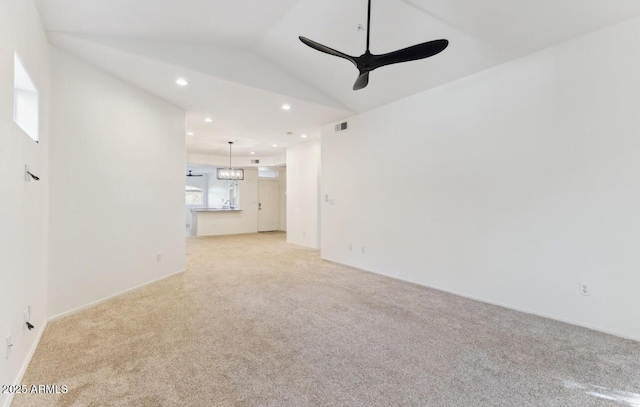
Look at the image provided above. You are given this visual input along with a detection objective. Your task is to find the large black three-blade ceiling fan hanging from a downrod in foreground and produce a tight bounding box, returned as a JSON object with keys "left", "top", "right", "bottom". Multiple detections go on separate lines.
{"left": 298, "top": 0, "right": 449, "bottom": 90}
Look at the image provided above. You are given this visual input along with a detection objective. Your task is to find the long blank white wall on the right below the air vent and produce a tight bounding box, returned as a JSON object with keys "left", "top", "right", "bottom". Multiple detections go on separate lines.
{"left": 320, "top": 20, "right": 640, "bottom": 339}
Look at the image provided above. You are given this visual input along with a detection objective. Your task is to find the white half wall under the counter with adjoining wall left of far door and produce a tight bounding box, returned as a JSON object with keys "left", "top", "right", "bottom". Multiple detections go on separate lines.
{"left": 192, "top": 168, "right": 258, "bottom": 236}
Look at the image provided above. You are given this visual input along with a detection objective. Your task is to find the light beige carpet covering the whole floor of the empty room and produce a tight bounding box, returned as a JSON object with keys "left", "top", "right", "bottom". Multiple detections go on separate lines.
{"left": 13, "top": 234, "right": 640, "bottom": 407}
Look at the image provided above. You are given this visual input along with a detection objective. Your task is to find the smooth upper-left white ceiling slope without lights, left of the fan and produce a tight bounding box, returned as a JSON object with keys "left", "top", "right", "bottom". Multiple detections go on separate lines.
{"left": 38, "top": 0, "right": 298, "bottom": 46}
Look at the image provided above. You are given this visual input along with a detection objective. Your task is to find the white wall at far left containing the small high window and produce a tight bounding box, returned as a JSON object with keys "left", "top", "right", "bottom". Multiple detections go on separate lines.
{"left": 0, "top": 0, "right": 50, "bottom": 405}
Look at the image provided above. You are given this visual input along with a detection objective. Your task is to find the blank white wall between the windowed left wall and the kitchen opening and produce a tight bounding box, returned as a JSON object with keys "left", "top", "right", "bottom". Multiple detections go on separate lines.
{"left": 49, "top": 49, "right": 185, "bottom": 316}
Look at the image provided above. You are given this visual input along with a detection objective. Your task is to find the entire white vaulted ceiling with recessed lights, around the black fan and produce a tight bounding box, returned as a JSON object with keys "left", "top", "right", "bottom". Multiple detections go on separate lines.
{"left": 38, "top": 0, "right": 640, "bottom": 156}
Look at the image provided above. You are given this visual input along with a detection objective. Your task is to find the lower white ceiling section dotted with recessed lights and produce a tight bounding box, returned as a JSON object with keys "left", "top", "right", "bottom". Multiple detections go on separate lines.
{"left": 49, "top": 33, "right": 350, "bottom": 158}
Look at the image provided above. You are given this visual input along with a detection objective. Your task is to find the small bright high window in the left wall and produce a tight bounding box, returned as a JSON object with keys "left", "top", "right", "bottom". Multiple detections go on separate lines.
{"left": 13, "top": 53, "right": 40, "bottom": 142}
